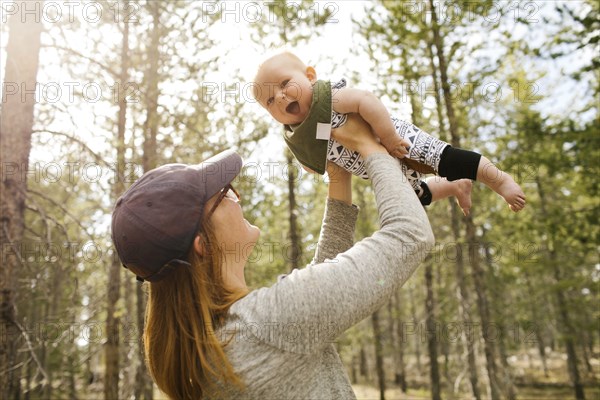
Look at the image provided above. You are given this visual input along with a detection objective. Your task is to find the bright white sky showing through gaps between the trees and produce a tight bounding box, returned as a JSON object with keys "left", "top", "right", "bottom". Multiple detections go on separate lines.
{"left": 0, "top": 0, "right": 597, "bottom": 268}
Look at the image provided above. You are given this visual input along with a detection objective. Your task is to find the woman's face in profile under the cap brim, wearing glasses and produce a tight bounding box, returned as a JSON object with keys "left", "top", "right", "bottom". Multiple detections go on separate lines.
{"left": 204, "top": 189, "right": 260, "bottom": 261}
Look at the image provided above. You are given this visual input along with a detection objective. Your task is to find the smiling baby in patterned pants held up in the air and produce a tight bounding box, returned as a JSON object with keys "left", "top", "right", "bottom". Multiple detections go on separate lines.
{"left": 253, "top": 52, "right": 526, "bottom": 215}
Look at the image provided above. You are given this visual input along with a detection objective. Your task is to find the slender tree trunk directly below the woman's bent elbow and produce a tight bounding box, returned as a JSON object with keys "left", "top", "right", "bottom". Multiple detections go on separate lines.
{"left": 425, "top": 259, "right": 442, "bottom": 400}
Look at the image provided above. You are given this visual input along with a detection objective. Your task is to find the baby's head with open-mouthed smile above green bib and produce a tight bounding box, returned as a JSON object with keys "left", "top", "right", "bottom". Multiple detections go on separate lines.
{"left": 253, "top": 52, "right": 317, "bottom": 125}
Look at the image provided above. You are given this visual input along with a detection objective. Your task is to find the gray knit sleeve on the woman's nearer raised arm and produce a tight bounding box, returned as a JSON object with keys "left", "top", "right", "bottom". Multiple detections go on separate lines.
{"left": 234, "top": 153, "right": 434, "bottom": 354}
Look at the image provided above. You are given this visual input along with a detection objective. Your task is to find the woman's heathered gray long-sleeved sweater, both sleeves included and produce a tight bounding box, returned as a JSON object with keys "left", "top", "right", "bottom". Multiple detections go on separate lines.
{"left": 209, "top": 154, "right": 434, "bottom": 400}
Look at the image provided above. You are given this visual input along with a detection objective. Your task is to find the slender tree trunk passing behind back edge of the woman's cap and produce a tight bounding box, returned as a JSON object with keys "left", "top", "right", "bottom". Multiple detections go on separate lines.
{"left": 104, "top": 7, "right": 129, "bottom": 399}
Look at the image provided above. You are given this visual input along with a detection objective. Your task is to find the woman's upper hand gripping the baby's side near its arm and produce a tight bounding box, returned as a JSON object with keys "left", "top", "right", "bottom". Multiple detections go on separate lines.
{"left": 331, "top": 114, "right": 388, "bottom": 158}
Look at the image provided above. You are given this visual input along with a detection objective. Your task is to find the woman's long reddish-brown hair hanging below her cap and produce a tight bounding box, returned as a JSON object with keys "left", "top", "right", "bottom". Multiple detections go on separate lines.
{"left": 144, "top": 221, "right": 247, "bottom": 399}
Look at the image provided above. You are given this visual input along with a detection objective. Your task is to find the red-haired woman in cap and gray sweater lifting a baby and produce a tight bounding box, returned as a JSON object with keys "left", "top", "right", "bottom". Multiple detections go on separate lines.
{"left": 112, "top": 116, "right": 433, "bottom": 399}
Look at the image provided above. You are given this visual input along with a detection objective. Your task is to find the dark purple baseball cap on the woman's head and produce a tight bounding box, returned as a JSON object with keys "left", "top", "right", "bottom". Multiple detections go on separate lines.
{"left": 112, "top": 150, "right": 242, "bottom": 282}
